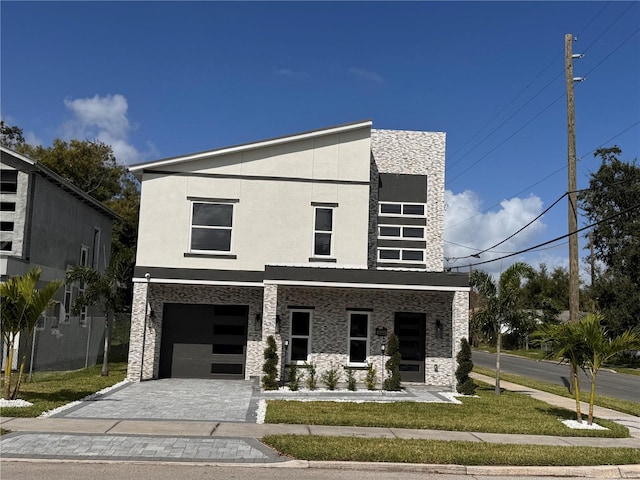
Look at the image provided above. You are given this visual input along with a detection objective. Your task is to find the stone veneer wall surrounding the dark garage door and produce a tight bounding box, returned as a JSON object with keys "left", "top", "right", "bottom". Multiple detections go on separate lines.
{"left": 127, "top": 282, "right": 264, "bottom": 381}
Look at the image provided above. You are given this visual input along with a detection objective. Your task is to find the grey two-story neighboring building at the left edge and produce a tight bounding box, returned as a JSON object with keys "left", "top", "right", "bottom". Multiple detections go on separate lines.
{"left": 0, "top": 147, "right": 117, "bottom": 371}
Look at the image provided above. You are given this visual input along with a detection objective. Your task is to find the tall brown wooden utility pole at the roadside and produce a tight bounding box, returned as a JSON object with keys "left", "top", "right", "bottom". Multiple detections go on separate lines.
{"left": 564, "top": 33, "right": 584, "bottom": 322}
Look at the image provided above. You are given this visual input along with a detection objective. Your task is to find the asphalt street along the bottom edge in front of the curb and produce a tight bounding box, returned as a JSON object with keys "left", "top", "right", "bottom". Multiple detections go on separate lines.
{"left": 0, "top": 461, "right": 624, "bottom": 480}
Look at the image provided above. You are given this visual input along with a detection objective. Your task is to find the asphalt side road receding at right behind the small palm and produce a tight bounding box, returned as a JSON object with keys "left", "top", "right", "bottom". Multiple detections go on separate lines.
{"left": 472, "top": 351, "right": 640, "bottom": 402}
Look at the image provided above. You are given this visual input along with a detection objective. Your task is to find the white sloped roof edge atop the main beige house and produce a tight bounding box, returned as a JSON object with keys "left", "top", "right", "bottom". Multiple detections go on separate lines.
{"left": 129, "top": 120, "right": 373, "bottom": 178}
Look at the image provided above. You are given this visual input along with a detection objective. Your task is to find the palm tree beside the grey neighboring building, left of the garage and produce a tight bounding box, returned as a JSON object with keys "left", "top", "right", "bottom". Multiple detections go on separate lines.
{"left": 65, "top": 250, "right": 133, "bottom": 377}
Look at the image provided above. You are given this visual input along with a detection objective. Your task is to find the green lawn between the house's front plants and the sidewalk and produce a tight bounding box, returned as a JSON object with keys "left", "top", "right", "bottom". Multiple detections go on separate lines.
{"left": 265, "top": 384, "right": 629, "bottom": 437}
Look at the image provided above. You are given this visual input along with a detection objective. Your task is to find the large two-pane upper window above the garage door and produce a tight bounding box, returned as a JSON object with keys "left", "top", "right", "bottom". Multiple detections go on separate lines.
{"left": 191, "top": 202, "right": 233, "bottom": 252}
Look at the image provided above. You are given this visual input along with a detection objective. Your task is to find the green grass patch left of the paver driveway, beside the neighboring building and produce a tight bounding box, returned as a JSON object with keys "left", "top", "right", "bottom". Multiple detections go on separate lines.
{"left": 0, "top": 362, "right": 127, "bottom": 417}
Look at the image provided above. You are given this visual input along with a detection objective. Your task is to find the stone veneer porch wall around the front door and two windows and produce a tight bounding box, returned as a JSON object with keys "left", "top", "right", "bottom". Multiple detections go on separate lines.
{"left": 276, "top": 286, "right": 466, "bottom": 388}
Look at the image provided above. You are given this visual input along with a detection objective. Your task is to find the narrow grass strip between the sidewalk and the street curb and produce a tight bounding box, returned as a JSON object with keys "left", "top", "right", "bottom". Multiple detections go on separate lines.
{"left": 262, "top": 435, "right": 640, "bottom": 466}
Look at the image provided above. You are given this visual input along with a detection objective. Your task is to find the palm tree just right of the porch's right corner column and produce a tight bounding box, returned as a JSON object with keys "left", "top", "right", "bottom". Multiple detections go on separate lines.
{"left": 471, "top": 262, "right": 535, "bottom": 395}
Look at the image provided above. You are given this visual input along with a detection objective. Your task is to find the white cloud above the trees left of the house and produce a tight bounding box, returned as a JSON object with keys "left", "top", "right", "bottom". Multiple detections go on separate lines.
{"left": 63, "top": 94, "right": 141, "bottom": 165}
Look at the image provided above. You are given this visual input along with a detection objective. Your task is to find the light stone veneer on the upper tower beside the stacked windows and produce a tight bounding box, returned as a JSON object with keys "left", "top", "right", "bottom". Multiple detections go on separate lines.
{"left": 371, "top": 129, "right": 446, "bottom": 272}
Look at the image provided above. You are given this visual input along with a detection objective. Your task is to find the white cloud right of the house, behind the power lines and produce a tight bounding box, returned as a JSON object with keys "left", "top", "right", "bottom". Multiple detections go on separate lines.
{"left": 444, "top": 190, "right": 546, "bottom": 273}
